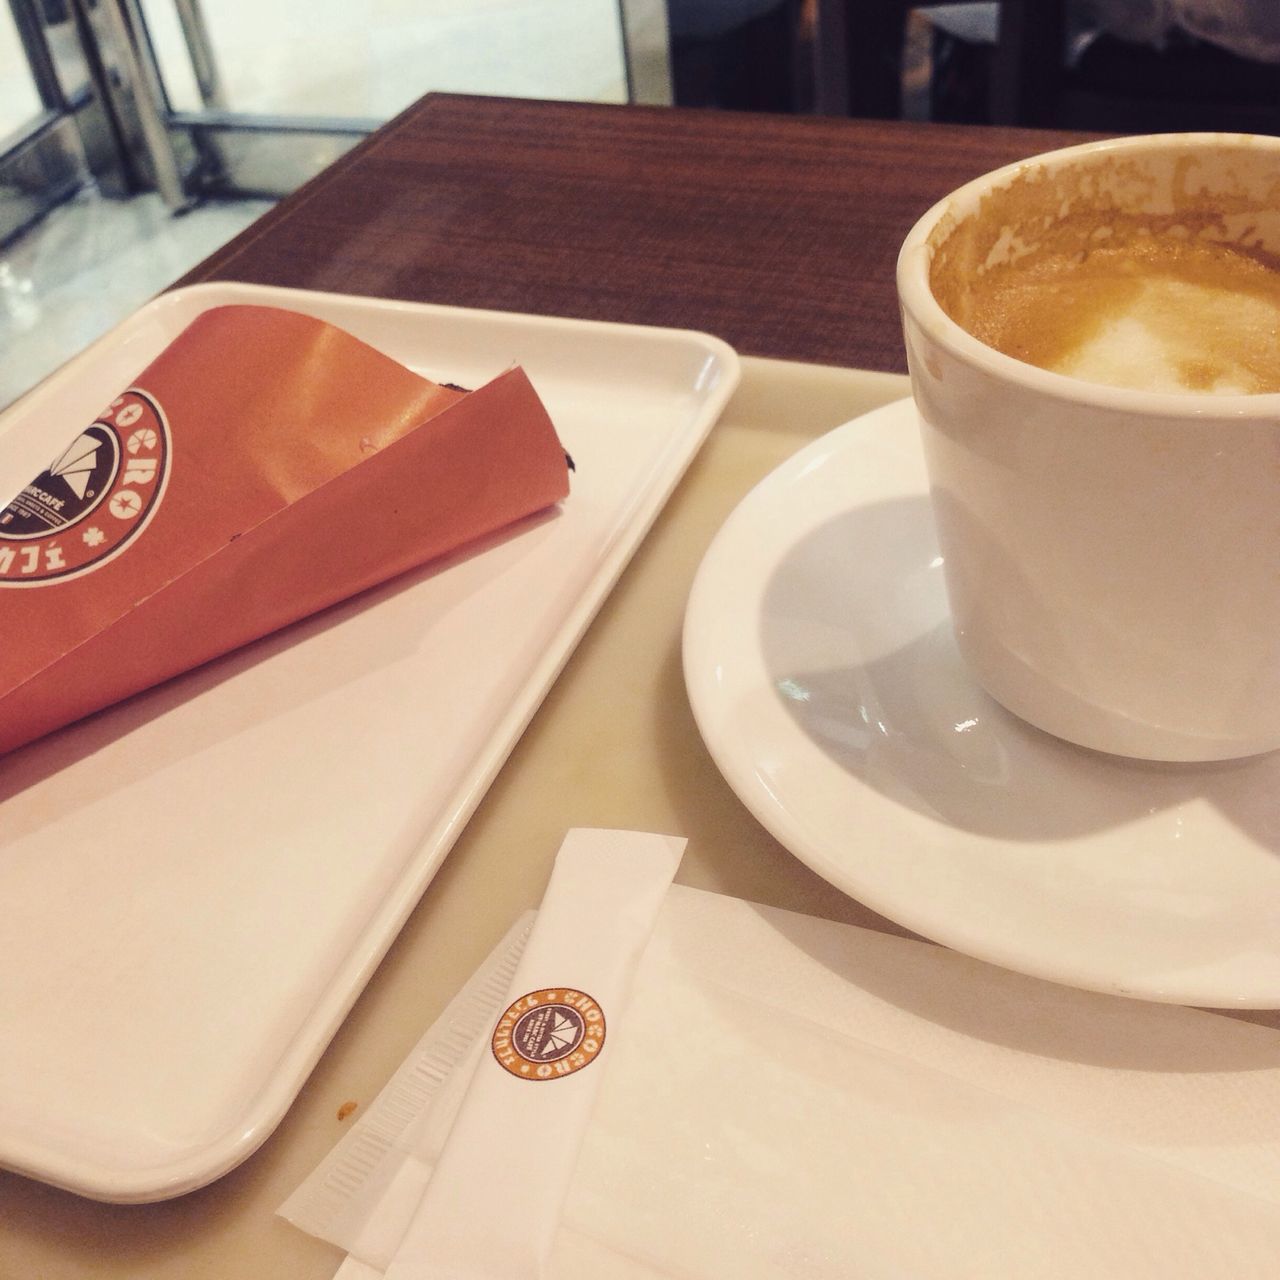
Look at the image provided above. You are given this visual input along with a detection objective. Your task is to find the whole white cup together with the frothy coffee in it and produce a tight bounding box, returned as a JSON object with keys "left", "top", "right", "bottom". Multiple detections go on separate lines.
{"left": 899, "top": 134, "right": 1280, "bottom": 760}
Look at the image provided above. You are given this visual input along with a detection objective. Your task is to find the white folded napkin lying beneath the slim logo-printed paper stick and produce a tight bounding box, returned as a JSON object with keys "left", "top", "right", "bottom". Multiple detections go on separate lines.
{"left": 282, "top": 839, "right": 1280, "bottom": 1280}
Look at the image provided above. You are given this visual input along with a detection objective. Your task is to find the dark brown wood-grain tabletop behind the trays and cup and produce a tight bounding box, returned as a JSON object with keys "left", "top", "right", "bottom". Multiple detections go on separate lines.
{"left": 186, "top": 93, "right": 1084, "bottom": 371}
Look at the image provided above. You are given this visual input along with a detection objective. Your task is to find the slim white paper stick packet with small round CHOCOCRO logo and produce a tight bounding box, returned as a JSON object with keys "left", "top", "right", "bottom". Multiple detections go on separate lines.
{"left": 385, "top": 829, "right": 685, "bottom": 1280}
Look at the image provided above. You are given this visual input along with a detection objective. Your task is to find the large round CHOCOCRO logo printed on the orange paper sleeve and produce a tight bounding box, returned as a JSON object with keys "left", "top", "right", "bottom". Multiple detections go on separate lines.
{"left": 0, "top": 390, "right": 170, "bottom": 586}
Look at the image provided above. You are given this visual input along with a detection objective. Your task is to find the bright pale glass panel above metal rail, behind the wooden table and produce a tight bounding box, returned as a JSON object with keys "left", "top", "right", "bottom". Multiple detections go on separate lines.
{"left": 143, "top": 0, "right": 627, "bottom": 120}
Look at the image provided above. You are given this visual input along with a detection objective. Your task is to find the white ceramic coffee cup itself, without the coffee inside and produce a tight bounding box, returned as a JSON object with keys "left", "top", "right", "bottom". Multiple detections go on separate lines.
{"left": 897, "top": 134, "right": 1280, "bottom": 760}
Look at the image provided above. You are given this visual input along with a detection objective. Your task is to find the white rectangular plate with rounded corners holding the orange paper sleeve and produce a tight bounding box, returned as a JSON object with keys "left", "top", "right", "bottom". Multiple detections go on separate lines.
{"left": 0, "top": 284, "right": 739, "bottom": 1202}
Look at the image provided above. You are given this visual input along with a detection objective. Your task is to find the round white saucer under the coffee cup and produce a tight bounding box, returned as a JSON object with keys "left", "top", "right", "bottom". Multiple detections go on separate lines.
{"left": 685, "top": 401, "right": 1280, "bottom": 1009}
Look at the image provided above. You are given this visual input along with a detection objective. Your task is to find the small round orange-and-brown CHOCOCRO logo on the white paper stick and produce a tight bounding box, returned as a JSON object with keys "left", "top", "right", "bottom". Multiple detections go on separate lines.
{"left": 493, "top": 987, "right": 604, "bottom": 1080}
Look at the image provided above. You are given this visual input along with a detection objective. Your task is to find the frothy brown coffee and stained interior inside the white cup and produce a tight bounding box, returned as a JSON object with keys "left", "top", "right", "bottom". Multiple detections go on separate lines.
{"left": 931, "top": 149, "right": 1280, "bottom": 393}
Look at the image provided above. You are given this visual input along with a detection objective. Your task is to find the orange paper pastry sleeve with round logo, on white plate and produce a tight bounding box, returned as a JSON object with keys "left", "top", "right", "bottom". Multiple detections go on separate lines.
{"left": 0, "top": 306, "right": 568, "bottom": 751}
